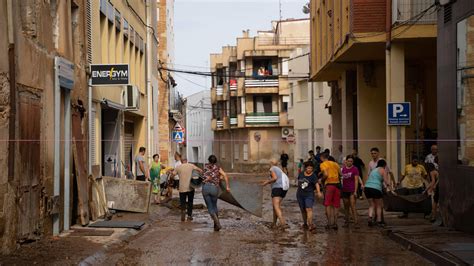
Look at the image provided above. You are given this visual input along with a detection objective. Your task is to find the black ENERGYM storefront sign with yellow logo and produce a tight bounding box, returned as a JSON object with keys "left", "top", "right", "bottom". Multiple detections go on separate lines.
{"left": 91, "top": 64, "right": 130, "bottom": 86}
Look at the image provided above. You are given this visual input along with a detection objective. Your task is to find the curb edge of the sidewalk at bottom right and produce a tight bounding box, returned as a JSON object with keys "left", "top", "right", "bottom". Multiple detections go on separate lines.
{"left": 385, "top": 229, "right": 465, "bottom": 265}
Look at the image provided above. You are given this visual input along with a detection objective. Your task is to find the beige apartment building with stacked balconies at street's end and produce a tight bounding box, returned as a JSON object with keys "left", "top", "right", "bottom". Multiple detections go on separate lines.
{"left": 211, "top": 19, "right": 309, "bottom": 172}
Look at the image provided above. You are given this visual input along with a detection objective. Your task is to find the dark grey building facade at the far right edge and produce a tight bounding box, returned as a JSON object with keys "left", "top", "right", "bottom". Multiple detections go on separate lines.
{"left": 438, "top": 0, "right": 474, "bottom": 233}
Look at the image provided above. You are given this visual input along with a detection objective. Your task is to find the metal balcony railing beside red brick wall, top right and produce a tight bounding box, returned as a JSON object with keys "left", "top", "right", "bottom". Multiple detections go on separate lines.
{"left": 392, "top": 0, "right": 437, "bottom": 24}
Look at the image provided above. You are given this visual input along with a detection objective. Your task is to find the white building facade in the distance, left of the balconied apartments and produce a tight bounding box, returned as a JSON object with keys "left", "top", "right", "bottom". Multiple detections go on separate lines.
{"left": 186, "top": 90, "right": 214, "bottom": 165}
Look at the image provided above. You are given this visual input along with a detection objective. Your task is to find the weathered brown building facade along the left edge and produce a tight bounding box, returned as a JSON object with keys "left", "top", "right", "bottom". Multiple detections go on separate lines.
{"left": 0, "top": 0, "right": 88, "bottom": 254}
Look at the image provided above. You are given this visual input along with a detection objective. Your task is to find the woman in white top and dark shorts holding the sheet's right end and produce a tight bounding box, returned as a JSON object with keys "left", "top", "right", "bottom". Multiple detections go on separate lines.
{"left": 262, "top": 159, "right": 288, "bottom": 229}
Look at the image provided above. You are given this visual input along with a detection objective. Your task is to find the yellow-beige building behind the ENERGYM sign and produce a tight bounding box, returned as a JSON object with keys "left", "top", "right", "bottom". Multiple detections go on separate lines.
{"left": 90, "top": 0, "right": 158, "bottom": 177}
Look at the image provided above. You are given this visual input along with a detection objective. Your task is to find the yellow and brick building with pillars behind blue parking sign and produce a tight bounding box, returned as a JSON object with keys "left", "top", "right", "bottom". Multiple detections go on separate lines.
{"left": 311, "top": 0, "right": 438, "bottom": 178}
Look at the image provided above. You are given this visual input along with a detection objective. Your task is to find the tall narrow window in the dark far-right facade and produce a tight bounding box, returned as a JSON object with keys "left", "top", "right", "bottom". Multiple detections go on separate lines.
{"left": 456, "top": 15, "right": 474, "bottom": 166}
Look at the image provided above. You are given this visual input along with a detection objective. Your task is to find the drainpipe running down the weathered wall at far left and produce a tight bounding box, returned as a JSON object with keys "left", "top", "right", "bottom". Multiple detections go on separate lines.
{"left": 7, "top": 0, "right": 16, "bottom": 182}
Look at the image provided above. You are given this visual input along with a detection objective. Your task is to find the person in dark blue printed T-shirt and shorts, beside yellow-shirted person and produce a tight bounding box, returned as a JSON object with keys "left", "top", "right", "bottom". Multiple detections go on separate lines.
{"left": 296, "top": 162, "right": 323, "bottom": 232}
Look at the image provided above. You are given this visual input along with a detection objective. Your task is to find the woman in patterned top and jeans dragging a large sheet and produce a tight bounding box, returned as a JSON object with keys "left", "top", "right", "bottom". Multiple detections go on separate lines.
{"left": 202, "top": 155, "right": 230, "bottom": 231}
